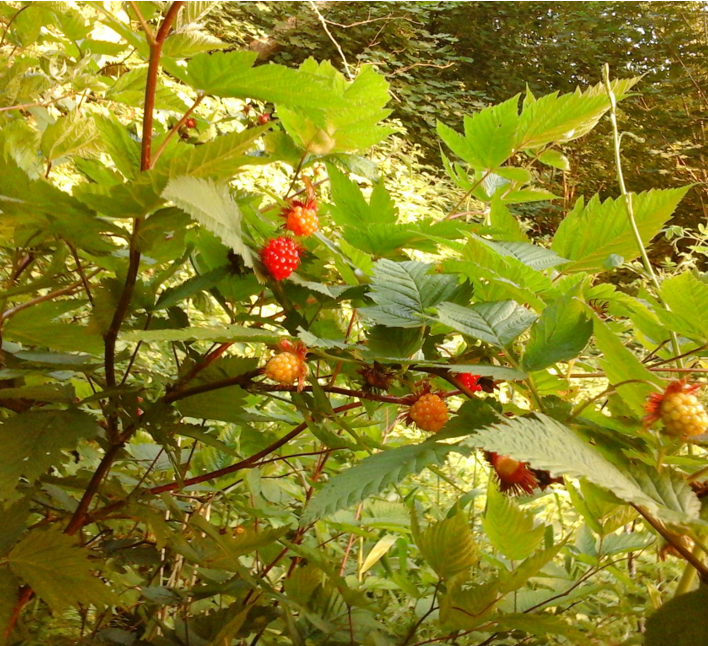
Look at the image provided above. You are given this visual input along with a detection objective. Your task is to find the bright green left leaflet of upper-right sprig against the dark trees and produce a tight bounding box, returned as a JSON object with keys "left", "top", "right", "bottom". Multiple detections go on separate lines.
{"left": 438, "top": 94, "right": 519, "bottom": 170}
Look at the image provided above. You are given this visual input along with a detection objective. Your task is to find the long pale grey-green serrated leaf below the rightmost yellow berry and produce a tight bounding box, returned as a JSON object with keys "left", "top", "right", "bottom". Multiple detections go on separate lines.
{"left": 472, "top": 414, "right": 699, "bottom": 522}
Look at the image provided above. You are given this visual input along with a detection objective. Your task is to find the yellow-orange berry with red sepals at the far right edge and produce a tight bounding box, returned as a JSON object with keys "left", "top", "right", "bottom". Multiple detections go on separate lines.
{"left": 644, "top": 381, "right": 708, "bottom": 439}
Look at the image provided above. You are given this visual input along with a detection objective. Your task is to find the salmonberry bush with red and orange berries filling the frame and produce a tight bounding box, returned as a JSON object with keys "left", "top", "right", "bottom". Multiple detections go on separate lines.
{"left": 0, "top": 2, "right": 708, "bottom": 646}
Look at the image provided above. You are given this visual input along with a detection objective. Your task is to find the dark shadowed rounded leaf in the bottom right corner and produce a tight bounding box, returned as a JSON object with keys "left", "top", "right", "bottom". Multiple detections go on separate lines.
{"left": 645, "top": 584, "right": 708, "bottom": 646}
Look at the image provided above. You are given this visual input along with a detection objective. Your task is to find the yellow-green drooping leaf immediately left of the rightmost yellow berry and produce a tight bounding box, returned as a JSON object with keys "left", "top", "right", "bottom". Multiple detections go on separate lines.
{"left": 593, "top": 317, "right": 665, "bottom": 418}
